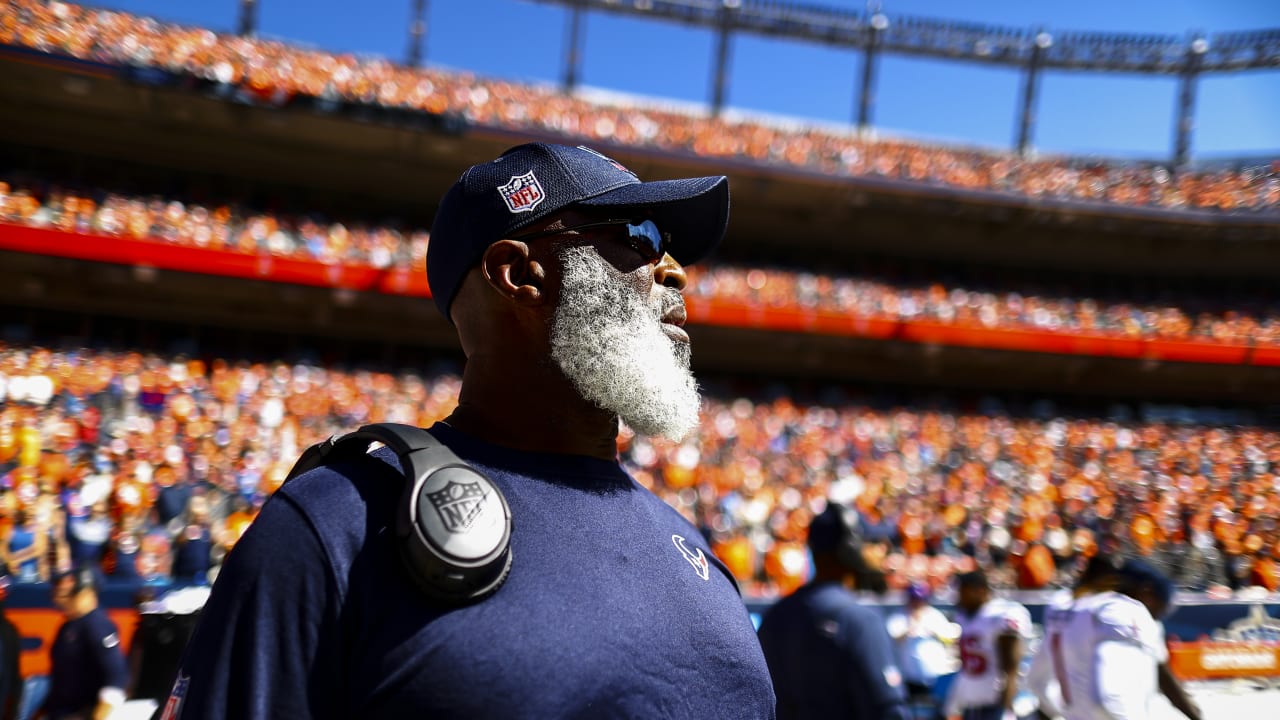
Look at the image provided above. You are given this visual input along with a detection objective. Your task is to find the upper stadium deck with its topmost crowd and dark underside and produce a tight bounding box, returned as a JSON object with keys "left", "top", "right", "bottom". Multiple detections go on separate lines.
{"left": 0, "top": 0, "right": 1280, "bottom": 288}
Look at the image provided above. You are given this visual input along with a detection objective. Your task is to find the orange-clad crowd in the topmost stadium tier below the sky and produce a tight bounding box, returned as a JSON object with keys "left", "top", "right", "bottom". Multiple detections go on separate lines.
{"left": 0, "top": 0, "right": 1280, "bottom": 211}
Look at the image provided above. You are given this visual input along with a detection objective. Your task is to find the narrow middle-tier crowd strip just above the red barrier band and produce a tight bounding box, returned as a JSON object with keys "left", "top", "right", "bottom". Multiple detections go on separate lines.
{"left": 0, "top": 178, "right": 1280, "bottom": 346}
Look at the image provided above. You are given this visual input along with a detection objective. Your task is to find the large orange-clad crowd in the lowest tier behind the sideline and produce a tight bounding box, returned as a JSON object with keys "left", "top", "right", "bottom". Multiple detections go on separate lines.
{"left": 0, "top": 345, "right": 1280, "bottom": 596}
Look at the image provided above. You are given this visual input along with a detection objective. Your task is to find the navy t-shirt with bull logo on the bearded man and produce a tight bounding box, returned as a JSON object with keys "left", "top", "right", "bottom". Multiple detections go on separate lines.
{"left": 168, "top": 424, "right": 773, "bottom": 720}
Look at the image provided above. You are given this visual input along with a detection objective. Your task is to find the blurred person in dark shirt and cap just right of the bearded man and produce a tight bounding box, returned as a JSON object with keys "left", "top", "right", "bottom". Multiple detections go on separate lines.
{"left": 759, "top": 503, "right": 911, "bottom": 720}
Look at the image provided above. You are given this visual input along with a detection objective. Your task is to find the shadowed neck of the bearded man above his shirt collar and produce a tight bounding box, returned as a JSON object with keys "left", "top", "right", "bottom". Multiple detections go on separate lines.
{"left": 445, "top": 356, "right": 618, "bottom": 460}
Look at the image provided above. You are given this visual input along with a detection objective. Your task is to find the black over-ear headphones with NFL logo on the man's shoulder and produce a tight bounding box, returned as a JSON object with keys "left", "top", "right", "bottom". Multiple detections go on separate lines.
{"left": 285, "top": 423, "right": 511, "bottom": 605}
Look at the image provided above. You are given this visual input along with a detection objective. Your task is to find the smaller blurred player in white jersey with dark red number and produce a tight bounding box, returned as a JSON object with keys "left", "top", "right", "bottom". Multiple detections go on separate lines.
{"left": 943, "top": 570, "right": 1032, "bottom": 720}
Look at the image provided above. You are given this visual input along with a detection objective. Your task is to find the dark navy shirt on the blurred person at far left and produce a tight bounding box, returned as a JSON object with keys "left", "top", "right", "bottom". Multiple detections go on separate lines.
{"left": 45, "top": 609, "right": 129, "bottom": 717}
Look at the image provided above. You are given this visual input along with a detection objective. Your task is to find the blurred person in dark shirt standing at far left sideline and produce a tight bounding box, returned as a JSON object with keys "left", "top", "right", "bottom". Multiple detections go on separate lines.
{"left": 42, "top": 568, "right": 129, "bottom": 720}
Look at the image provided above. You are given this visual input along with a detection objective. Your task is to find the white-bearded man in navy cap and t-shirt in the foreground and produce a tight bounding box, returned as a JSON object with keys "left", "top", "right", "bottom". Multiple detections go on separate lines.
{"left": 164, "top": 143, "right": 774, "bottom": 720}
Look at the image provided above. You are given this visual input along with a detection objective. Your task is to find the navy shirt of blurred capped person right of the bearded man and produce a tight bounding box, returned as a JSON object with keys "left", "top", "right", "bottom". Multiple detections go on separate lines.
{"left": 760, "top": 582, "right": 911, "bottom": 720}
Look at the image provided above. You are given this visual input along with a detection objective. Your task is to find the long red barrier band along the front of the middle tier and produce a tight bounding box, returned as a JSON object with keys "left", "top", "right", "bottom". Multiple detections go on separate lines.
{"left": 0, "top": 223, "right": 1280, "bottom": 366}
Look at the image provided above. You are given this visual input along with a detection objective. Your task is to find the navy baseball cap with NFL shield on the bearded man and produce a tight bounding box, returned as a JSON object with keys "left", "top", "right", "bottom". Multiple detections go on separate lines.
{"left": 426, "top": 142, "right": 728, "bottom": 322}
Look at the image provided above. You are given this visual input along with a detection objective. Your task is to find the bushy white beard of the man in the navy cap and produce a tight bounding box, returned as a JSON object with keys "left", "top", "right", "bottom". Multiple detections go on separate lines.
{"left": 550, "top": 247, "right": 701, "bottom": 441}
